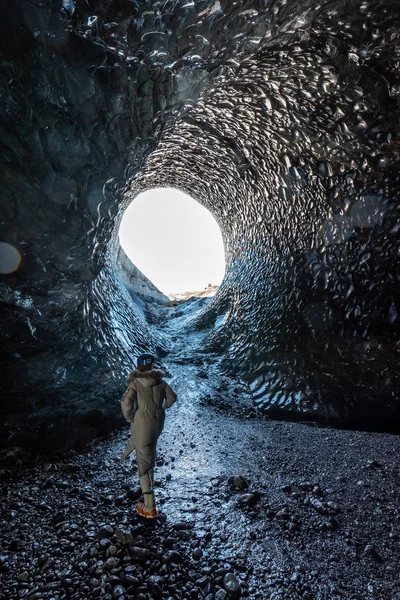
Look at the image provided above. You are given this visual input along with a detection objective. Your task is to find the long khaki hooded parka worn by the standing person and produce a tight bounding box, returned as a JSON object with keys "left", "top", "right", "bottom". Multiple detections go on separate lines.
{"left": 121, "top": 369, "right": 176, "bottom": 477}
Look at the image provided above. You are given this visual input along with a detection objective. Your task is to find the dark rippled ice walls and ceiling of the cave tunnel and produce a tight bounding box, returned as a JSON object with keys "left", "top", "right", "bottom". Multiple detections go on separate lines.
{"left": 0, "top": 0, "right": 400, "bottom": 447}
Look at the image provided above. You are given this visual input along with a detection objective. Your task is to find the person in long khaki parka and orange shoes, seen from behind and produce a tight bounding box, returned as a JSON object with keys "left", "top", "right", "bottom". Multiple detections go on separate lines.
{"left": 121, "top": 354, "right": 176, "bottom": 519}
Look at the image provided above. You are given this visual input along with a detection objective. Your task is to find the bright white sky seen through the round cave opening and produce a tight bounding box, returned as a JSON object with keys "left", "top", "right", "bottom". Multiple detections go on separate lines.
{"left": 119, "top": 188, "right": 225, "bottom": 294}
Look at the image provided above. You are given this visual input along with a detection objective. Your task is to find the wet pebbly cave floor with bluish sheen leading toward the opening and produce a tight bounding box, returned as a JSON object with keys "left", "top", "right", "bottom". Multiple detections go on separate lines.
{"left": 0, "top": 300, "right": 400, "bottom": 600}
